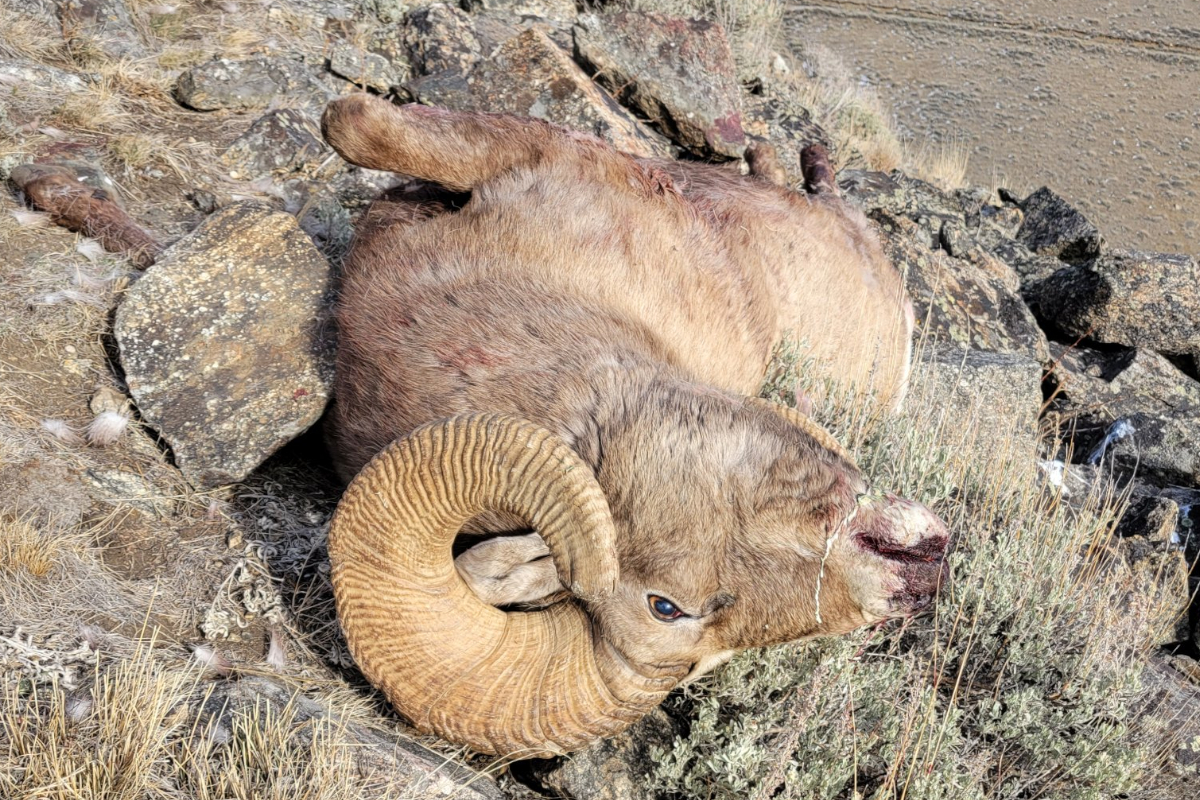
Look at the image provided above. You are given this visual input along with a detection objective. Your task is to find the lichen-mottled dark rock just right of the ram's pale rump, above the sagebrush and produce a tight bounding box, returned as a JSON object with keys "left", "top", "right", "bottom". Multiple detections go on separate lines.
{"left": 872, "top": 211, "right": 1049, "bottom": 362}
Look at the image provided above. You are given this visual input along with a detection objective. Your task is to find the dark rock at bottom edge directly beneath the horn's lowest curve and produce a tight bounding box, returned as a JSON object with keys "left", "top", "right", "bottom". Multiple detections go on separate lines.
{"left": 535, "top": 709, "right": 676, "bottom": 800}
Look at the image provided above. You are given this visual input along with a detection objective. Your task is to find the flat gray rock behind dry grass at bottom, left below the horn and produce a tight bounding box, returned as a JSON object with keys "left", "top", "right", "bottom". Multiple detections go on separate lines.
{"left": 200, "top": 675, "right": 504, "bottom": 800}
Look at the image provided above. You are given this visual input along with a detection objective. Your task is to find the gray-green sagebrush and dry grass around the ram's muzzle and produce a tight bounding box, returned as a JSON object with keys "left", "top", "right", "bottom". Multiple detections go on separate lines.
{"left": 656, "top": 340, "right": 1178, "bottom": 800}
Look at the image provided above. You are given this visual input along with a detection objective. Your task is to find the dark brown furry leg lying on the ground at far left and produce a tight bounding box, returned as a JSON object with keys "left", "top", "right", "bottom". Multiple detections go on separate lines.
{"left": 10, "top": 164, "right": 162, "bottom": 267}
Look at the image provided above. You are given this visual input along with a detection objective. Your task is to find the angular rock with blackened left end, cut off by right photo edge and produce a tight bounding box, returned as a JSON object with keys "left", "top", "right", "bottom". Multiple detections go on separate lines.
{"left": 1026, "top": 251, "right": 1200, "bottom": 369}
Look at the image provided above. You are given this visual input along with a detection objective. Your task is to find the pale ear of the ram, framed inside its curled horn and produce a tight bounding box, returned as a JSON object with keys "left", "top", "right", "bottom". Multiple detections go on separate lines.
{"left": 454, "top": 534, "right": 565, "bottom": 606}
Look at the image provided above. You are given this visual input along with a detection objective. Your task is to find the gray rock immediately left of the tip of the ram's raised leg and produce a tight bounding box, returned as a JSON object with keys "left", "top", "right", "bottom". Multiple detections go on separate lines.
{"left": 221, "top": 108, "right": 332, "bottom": 179}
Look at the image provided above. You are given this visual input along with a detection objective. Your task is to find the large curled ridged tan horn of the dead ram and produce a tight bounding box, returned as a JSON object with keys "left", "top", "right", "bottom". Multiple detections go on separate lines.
{"left": 329, "top": 414, "right": 677, "bottom": 757}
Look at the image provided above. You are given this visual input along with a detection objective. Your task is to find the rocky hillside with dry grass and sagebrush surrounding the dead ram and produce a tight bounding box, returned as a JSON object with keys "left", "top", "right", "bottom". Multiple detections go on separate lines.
{"left": 0, "top": 0, "right": 1200, "bottom": 800}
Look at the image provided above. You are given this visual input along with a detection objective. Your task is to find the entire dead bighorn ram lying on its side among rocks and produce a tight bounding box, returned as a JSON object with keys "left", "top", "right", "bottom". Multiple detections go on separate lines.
{"left": 323, "top": 95, "right": 947, "bottom": 756}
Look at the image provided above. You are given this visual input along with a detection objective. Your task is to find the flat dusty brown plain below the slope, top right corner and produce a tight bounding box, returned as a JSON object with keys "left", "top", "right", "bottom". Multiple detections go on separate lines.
{"left": 787, "top": 0, "right": 1200, "bottom": 253}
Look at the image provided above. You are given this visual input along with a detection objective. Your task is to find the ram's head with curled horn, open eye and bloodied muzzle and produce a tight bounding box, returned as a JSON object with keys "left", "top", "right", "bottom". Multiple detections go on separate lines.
{"left": 330, "top": 392, "right": 948, "bottom": 757}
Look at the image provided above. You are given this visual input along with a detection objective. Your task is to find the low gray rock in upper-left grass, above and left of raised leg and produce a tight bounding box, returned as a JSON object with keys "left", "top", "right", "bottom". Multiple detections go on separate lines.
{"left": 175, "top": 58, "right": 334, "bottom": 112}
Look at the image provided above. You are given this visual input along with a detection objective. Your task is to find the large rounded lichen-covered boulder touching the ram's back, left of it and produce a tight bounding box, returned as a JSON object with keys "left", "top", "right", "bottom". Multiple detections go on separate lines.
{"left": 115, "top": 204, "right": 332, "bottom": 488}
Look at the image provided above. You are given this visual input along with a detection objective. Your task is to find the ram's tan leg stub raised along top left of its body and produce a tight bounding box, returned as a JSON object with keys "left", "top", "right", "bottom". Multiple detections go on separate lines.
{"left": 320, "top": 95, "right": 557, "bottom": 192}
